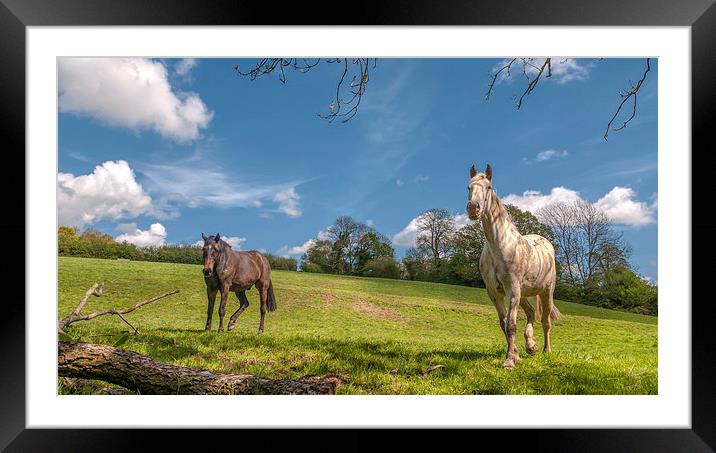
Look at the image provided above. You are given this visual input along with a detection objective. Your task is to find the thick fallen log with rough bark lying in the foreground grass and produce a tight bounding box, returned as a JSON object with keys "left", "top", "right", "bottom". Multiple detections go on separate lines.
{"left": 57, "top": 341, "right": 341, "bottom": 395}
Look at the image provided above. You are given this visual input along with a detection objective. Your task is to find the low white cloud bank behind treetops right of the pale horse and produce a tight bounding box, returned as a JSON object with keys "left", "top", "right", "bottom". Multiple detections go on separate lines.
{"left": 502, "top": 186, "right": 657, "bottom": 228}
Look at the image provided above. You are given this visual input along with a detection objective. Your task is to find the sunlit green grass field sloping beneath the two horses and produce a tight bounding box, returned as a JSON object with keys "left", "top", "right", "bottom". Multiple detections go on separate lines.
{"left": 58, "top": 257, "right": 658, "bottom": 394}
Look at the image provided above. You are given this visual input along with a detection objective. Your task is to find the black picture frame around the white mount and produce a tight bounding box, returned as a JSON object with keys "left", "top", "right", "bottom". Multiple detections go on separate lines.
{"left": 0, "top": 0, "right": 716, "bottom": 452}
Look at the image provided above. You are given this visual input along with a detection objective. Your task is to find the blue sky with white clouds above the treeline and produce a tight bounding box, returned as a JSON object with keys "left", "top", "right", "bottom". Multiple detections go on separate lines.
{"left": 58, "top": 59, "right": 658, "bottom": 280}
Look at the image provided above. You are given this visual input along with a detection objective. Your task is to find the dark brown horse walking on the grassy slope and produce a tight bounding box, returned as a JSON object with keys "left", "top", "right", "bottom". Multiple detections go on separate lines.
{"left": 201, "top": 233, "right": 276, "bottom": 333}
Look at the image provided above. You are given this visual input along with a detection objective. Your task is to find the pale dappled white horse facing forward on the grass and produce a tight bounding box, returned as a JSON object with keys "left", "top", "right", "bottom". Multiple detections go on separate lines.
{"left": 467, "top": 164, "right": 561, "bottom": 369}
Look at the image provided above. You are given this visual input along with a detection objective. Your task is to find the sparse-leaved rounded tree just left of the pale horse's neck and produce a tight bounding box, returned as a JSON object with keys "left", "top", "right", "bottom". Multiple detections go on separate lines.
{"left": 415, "top": 209, "right": 455, "bottom": 267}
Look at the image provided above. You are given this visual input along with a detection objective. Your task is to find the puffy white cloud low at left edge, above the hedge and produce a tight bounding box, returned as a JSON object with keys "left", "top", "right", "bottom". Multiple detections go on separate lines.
{"left": 57, "top": 160, "right": 153, "bottom": 227}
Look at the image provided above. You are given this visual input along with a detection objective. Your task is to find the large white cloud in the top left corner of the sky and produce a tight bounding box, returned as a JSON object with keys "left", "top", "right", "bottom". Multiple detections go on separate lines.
{"left": 58, "top": 58, "right": 213, "bottom": 142}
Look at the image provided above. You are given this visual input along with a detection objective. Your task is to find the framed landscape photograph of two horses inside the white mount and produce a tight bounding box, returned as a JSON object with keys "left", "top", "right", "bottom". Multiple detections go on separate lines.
{"left": 57, "top": 54, "right": 667, "bottom": 396}
